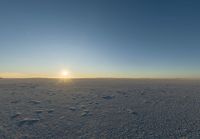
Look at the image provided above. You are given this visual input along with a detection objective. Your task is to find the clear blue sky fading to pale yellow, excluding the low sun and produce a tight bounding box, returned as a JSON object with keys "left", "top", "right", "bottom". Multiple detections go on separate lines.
{"left": 0, "top": 0, "right": 200, "bottom": 78}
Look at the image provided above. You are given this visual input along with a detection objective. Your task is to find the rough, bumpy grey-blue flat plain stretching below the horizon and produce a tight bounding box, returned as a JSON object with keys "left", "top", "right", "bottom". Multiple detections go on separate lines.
{"left": 0, "top": 79, "right": 200, "bottom": 139}
